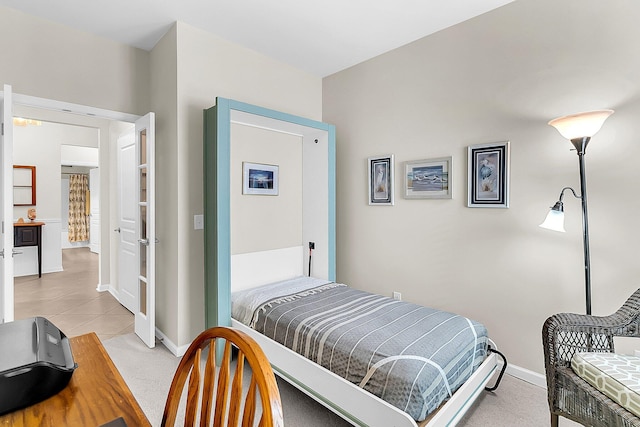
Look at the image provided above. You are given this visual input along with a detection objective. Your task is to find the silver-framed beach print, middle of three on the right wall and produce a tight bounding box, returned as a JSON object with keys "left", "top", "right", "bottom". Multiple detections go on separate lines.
{"left": 404, "top": 157, "right": 451, "bottom": 199}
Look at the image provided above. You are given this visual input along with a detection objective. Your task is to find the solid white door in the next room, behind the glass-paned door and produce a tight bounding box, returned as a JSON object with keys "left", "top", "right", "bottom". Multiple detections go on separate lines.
{"left": 116, "top": 130, "right": 138, "bottom": 313}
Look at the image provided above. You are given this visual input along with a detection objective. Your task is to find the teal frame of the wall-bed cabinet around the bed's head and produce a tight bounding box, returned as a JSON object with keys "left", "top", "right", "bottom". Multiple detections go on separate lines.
{"left": 204, "top": 97, "right": 336, "bottom": 328}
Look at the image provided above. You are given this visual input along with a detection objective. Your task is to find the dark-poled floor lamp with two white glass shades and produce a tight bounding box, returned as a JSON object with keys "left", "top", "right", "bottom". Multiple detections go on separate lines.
{"left": 540, "top": 110, "right": 613, "bottom": 314}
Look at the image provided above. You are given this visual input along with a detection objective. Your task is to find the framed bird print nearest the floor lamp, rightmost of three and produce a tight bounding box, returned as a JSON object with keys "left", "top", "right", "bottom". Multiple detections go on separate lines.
{"left": 467, "top": 141, "right": 509, "bottom": 208}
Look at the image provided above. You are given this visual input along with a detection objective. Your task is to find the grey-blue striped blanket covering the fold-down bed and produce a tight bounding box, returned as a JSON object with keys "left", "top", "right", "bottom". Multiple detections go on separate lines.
{"left": 232, "top": 278, "right": 487, "bottom": 421}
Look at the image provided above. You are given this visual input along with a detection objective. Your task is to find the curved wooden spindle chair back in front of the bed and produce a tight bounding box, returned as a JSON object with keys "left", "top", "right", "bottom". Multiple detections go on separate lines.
{"left": 161, "top": 327, "right": 283, "bottom": 427}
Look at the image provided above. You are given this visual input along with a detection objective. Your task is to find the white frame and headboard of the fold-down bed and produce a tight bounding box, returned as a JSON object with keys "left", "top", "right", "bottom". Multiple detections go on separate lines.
{"left": 231, "top": 246, "right": 498, "bottom": 427}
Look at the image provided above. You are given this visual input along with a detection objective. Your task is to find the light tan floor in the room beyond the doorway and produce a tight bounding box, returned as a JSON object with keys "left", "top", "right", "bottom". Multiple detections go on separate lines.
{"left": 15, "top": 248, "right": 133, "bottom": 341}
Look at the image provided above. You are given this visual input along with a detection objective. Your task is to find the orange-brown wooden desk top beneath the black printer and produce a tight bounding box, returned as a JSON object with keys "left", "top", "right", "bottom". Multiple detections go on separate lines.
{"left": 0, "top": 333, "right": 151, "bottom": 427}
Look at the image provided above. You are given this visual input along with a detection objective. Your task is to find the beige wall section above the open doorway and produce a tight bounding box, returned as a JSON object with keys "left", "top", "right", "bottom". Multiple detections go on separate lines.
{"left": 0, "top": 7, "right": 149, "bottom": 114}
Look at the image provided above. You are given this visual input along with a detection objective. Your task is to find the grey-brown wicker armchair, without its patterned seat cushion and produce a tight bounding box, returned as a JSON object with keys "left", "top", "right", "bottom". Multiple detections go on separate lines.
{"left": 542, "top": 289, "right": 640, "bottom": 427}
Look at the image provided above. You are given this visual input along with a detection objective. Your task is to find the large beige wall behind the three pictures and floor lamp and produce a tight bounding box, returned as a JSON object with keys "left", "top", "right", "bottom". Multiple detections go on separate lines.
{"left": 323, "top": 0, "right": 640, "bottom": 373}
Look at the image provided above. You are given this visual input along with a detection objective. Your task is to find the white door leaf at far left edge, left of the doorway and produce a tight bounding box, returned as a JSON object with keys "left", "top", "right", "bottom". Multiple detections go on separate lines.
{"left": 0, "top": 85, "right": 14, "bottom": 323}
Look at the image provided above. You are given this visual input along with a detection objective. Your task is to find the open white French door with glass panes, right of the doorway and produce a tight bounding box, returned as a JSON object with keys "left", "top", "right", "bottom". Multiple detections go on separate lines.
{"left": 134, "top": 113, "right": 156, "bottom": 347}
